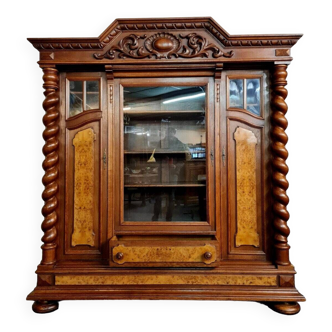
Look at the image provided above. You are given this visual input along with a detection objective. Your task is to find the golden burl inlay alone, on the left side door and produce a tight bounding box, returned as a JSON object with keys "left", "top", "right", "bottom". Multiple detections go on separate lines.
{"left": 72, "top": 128, "right": 96, "bottom": 247}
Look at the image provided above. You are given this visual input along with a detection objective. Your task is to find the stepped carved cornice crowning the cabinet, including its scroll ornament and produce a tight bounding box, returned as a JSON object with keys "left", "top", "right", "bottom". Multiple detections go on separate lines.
{"left": 27, "top": 16, "right": 304, "bottom": 63}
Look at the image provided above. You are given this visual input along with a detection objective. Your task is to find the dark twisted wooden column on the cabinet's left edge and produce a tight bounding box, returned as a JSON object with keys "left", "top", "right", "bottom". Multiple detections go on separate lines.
{"left": 41, "top": 68, "right": 59, "bottom": 265}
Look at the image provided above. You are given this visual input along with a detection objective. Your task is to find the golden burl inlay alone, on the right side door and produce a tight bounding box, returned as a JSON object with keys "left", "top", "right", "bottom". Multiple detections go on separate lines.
{"left": 234, "top": 127, "right": 259, "bottom": 247}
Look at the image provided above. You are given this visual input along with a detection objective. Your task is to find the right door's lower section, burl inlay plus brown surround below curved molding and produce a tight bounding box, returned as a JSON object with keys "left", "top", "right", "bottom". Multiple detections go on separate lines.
{"left": 227, "top": 118, "right": 265, "bottom": 259}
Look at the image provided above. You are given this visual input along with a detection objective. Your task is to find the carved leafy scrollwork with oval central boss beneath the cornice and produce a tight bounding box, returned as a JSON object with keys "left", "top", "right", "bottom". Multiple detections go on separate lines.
{"left": 94, "top": 33, "right": 234, "bottom": 60}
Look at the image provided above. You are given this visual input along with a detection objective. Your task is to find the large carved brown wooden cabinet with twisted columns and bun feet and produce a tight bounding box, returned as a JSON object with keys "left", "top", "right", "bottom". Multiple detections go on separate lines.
{"left": 27, "top": 16, "right": 306, "bottom": 313}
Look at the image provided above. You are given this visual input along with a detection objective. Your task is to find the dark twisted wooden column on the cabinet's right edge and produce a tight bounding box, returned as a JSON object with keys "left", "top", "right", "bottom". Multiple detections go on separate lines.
{"left": 272, "top": 65, "right": 291, "bottom": 265}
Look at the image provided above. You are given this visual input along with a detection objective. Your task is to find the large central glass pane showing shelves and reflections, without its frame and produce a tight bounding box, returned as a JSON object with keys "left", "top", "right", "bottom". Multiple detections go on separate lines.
{"left": 123, "top": 86, "right": 207, "bottom": 222}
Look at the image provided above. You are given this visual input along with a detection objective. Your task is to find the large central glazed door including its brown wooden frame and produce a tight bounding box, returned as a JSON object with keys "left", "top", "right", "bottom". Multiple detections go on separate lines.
{"left": 112, "top": 78, "right": 215, "bottom": 235}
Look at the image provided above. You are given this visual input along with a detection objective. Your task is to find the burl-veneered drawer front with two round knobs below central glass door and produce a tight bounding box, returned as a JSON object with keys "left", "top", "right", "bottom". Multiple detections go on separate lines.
{"left": 113, "top": 245, "right": 217, "bottom": 264}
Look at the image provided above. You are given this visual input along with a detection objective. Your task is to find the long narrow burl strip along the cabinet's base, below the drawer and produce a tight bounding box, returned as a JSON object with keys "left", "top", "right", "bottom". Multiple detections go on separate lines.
{"left": 55, "top": 274, "right": 277, "bottom": 286}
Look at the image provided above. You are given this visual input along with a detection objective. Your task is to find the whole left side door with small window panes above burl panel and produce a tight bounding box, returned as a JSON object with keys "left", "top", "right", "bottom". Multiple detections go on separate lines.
{"left": 62, "top": 73, "right": 107, "bottom": 260}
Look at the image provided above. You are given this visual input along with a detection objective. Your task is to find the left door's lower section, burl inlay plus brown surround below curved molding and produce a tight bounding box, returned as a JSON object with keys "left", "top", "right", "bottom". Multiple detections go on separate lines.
{"left": 65, "top": 122, "right": 100, "bottom": 254}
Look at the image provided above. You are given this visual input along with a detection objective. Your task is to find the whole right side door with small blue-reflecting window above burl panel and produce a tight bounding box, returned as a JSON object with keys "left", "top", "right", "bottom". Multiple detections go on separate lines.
{"left": 222, "top": 71, "right": 270, "bottom": 260}
